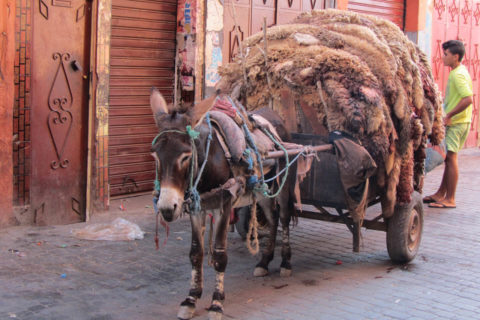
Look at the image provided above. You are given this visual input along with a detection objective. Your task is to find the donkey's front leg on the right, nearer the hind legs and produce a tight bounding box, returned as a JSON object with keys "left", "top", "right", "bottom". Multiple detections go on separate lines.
{"left": 208, "top": 200, "right": 232, "bottom": 320}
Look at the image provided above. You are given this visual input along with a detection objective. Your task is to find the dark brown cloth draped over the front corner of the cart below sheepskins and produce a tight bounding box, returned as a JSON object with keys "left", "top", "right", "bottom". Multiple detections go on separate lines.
{"left": 329, "top": 131, "right": 377, "bottom": 222}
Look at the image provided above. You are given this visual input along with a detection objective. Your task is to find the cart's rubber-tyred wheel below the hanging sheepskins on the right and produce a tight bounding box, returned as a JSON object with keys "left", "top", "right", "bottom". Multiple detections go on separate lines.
{"left": 387, "top": 191, "right": 423, "bottom": 263}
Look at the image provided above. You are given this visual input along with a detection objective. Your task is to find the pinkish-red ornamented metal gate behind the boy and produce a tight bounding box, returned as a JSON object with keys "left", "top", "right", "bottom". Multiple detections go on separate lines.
{"left": 432, "top": 0, "right": 480, "bottom": 147}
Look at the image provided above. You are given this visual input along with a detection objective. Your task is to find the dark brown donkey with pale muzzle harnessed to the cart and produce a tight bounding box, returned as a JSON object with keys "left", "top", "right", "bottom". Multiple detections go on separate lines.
{"left": 150, "top": 88, "right": 296, "bottom": 319}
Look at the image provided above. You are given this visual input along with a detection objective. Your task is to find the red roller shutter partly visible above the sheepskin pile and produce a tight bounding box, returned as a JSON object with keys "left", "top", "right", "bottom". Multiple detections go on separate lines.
{"left": 348, "top": 0, "right": 405, "bottom": 30}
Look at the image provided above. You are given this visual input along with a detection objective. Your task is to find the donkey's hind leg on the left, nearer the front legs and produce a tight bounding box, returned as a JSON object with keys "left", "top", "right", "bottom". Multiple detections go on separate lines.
{"left": 251, "top": 198, "right": 278, "bottom": 277}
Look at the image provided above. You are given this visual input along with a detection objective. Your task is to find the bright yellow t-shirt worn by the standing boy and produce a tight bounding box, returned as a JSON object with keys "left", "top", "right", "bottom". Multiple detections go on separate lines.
{"left": 443, "top": 64, "right": 473, "bottom": 124}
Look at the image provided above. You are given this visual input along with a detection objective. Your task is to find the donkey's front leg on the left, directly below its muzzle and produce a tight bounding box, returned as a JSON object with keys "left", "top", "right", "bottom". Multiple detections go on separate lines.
{"left": 177, "top": 213, "right": 205, "bottom": 320}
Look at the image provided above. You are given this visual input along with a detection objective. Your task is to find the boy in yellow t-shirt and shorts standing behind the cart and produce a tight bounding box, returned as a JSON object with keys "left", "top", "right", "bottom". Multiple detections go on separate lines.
{"left": 423, "top": 40, "right": 473, "bottom": 208}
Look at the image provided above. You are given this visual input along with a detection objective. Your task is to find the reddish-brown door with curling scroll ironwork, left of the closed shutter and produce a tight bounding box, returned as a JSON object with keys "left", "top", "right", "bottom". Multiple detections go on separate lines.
{"left": 30, "top": 0, "right": 91, "bottom": 225}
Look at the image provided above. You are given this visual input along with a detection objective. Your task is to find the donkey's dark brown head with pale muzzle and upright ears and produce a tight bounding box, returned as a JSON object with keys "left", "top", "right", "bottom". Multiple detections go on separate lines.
{"left": 150, "top": 88, "right": 215, "bottom": 222}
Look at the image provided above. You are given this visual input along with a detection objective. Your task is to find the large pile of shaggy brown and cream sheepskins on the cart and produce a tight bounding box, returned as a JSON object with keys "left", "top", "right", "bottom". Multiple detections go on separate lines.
{"left": 218, "top": 9, "right": 444, "bottom": 217}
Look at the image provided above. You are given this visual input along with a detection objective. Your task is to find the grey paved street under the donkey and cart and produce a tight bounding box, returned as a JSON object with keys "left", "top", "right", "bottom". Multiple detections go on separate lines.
{"left": 0, "top": 148, "right": 480, "bottom": 320}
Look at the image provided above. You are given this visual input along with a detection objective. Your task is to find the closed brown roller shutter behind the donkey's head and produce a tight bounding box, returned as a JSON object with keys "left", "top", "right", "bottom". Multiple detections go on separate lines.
{"left": 108, "top": 0, "right": 177, "bottom": 196}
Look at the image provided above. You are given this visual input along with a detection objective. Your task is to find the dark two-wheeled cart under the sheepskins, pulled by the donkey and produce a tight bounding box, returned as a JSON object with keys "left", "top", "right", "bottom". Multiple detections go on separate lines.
{"left": 236, "top": 133, "right": 423, "bottom": 263}
